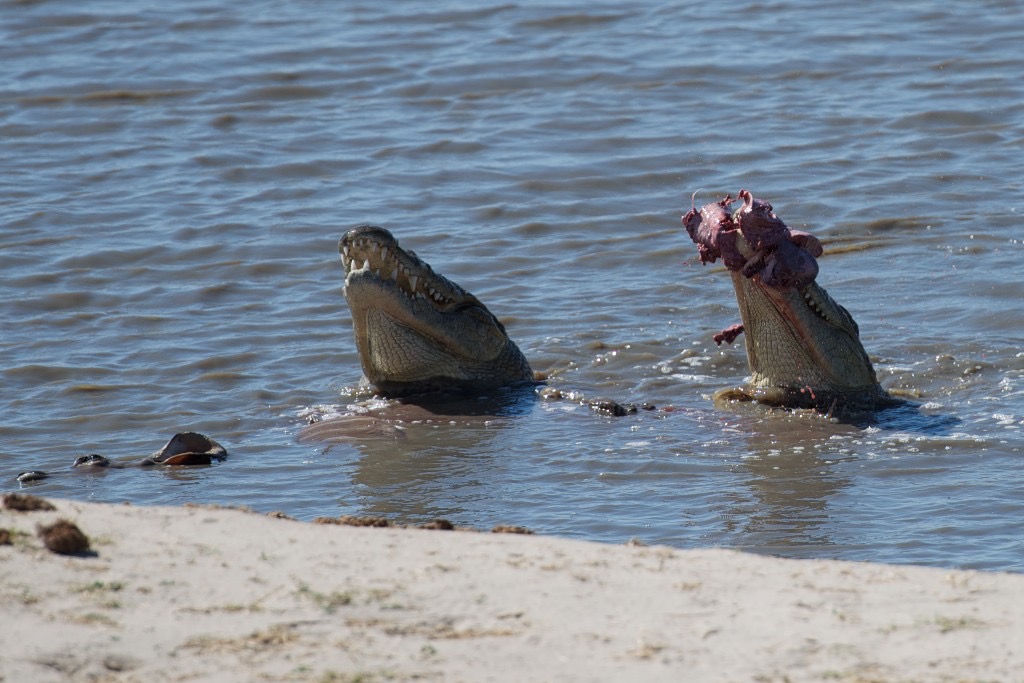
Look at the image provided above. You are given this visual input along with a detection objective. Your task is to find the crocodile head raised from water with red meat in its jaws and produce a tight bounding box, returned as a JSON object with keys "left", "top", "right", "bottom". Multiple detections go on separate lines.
{"left": 683, "top": 189, "right": 901, "bottom": 415}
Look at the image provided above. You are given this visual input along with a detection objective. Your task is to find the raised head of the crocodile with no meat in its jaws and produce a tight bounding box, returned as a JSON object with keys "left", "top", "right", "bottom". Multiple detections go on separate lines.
{"left": 338, "top": 225, "right": 534, "bottom": 396}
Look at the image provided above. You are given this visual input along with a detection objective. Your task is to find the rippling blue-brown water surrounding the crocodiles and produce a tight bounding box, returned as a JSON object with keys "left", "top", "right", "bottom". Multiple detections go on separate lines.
{"left": 0, "top": 0, "right": 1024, "bottom": 570}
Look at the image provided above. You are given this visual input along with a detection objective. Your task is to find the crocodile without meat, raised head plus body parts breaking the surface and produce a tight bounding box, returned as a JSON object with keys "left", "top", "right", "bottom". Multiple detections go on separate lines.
{"left": 299, "top": 225, "right": 653, "bottom": 441}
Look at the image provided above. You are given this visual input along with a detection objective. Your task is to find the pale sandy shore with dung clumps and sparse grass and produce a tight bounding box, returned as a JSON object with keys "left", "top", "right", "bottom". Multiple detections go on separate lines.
{"left": 0, "top": 500, "right": 1024, "bottom": 683}
